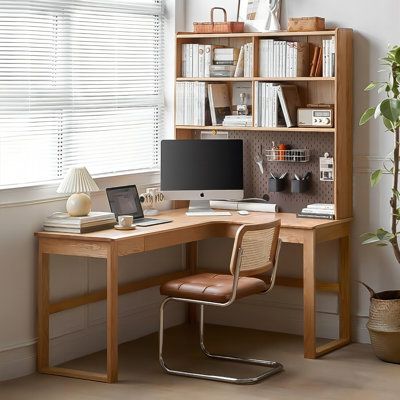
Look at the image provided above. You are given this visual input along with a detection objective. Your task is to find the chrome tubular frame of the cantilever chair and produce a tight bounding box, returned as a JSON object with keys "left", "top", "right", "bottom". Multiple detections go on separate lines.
{"left": 159, "top": 239, "right": 283, "bottom": 384}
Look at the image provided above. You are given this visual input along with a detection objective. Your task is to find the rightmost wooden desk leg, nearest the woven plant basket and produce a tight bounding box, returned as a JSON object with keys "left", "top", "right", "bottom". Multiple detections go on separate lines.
{"left": 339, "top": 236, "right": 351, "bottom": 343}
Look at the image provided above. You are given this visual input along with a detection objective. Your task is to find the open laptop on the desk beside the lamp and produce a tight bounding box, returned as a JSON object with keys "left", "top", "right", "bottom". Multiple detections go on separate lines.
{"left": 106, "top": 185, "right": 172, "bottom": 226}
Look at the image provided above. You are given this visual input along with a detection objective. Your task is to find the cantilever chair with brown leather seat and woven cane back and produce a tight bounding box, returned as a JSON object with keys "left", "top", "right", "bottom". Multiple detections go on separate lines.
{"left": 159, "top": 220, "right": 283, "bottom": 384}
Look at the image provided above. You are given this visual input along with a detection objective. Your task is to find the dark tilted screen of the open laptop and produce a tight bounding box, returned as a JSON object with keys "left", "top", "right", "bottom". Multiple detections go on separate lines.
{"left": 106, "top": 185, "right": 143, "bottom": 219}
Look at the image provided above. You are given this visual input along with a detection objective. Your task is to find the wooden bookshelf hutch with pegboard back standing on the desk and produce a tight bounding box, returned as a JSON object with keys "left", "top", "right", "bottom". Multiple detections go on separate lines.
{"left": 175, "top": 28, "right": 352, "bottom": 219}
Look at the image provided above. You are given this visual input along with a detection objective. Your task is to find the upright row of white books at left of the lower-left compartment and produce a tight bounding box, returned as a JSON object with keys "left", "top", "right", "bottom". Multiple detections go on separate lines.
{"left": 175, "top": 82, "right": 211, "bottom": 126}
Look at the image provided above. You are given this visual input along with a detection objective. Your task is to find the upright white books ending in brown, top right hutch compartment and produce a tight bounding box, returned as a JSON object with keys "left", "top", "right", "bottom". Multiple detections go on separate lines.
{"left": 259, "top": 39, "right": 309, "bottom": 78}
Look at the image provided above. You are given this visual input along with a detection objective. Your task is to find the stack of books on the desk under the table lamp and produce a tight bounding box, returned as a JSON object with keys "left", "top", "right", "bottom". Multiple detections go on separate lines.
{"left": 43, "top": 212, "right": 116, "bottom": 233}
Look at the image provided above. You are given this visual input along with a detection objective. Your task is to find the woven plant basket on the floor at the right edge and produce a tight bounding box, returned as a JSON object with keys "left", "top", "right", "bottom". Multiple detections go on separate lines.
{"left": 363, "top": 283, "right": 400, "bottom": 364}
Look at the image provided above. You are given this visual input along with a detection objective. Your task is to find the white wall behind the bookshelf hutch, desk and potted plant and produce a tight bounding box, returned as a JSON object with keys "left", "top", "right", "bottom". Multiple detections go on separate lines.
{"left": 186, "top": 0, "right": 400, "bottom": 341}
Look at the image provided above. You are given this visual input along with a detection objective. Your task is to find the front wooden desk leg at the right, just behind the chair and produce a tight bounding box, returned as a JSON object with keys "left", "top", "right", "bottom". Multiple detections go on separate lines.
{"left": 303, "top": 230, "right": 316, "bottom": 358}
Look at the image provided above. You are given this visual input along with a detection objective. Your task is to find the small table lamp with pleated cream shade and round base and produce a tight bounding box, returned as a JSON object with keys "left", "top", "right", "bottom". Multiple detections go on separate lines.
{"left": 57, "top": 167, "right": 100, "bottom": 217}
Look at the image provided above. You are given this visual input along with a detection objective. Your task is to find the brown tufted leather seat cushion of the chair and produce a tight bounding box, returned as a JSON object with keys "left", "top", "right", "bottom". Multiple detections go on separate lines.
{"left": 160, "top": 273, "right": 268, "bottom": 303}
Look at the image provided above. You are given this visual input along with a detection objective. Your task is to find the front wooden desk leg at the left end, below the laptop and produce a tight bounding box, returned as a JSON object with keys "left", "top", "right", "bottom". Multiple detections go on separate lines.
{"left": 107, "top": 244, "right": 118, "bottom": 383}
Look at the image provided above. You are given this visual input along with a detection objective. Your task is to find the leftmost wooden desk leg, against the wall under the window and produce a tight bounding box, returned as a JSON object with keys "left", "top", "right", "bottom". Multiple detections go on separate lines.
{"left": 37, "top": 245, "right": 50, "bottom": 372}
